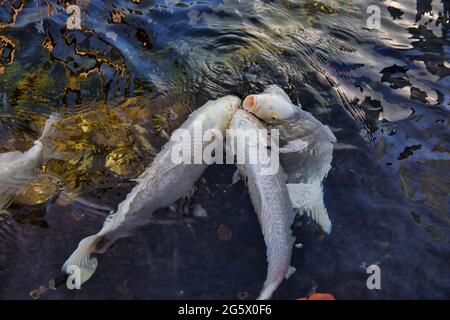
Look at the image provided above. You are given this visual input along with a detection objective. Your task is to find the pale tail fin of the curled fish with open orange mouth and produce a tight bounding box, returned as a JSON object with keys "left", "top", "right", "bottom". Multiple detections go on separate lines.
{"left": 287, "top": 183, "right": 332, "bottom": 234}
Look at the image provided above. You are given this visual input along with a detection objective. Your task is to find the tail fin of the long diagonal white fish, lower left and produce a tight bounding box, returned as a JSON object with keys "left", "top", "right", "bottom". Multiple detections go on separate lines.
{"left": 62, "top": 235, "right": 103, "bottom": 284}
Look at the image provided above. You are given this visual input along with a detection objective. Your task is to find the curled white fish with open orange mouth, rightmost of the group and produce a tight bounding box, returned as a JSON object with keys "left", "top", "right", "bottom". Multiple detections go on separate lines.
{"left": 243, "top": 85, "right": 336, "bottom": 233}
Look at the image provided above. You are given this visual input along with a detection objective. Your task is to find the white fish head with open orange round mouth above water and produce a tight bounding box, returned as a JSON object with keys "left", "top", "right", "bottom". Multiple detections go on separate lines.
{"left": 243, "top": 93, "right": 296, "bottom": 121}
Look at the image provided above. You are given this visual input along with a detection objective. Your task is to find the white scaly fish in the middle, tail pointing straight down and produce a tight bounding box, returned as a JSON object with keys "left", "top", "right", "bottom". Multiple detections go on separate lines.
{"left": 231, "top": 110, "right": 295, "bottom": 300}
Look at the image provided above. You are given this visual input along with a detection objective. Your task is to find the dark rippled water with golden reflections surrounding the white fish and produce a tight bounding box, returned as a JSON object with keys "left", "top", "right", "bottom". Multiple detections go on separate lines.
{"left": 0, "top": 0, "right": 450, "bottom": 299}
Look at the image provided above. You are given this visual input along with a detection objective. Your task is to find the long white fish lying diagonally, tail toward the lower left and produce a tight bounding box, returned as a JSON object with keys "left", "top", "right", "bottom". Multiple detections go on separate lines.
{"left": 62, "top": 96, "right": 241, "bottom": 283}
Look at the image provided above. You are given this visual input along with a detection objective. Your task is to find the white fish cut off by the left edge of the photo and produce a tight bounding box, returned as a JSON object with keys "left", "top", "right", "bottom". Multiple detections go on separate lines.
{"left": 0, "top": 114, "right": 59, "bottom": 210}
